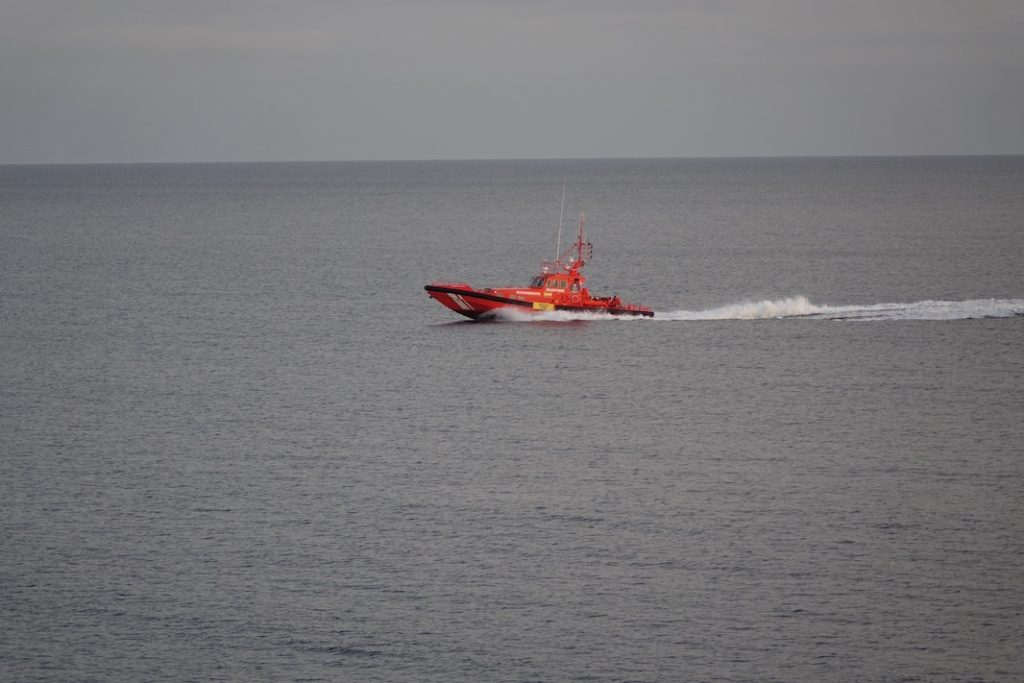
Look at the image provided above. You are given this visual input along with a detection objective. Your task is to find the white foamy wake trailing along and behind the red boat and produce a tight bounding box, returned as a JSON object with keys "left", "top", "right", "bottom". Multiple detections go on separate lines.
{"left": 483, "top": 296, "right": 1024, "bottom": 323}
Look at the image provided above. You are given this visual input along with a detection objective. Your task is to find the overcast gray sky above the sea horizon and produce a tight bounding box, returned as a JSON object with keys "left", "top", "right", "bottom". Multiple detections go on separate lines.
{"left": 0, "top": 0, "right": 1024, "bottom": 163}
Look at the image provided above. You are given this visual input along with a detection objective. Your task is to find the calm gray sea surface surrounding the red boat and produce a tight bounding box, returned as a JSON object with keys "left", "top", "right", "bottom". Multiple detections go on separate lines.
{"left": 0, "top": 157, "right": 1024, "bottom": 683}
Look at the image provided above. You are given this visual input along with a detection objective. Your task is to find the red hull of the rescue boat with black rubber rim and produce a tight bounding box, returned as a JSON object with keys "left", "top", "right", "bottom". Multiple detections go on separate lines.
{"left": 423, "top": 283, "right": 654, "bottom": 319}
